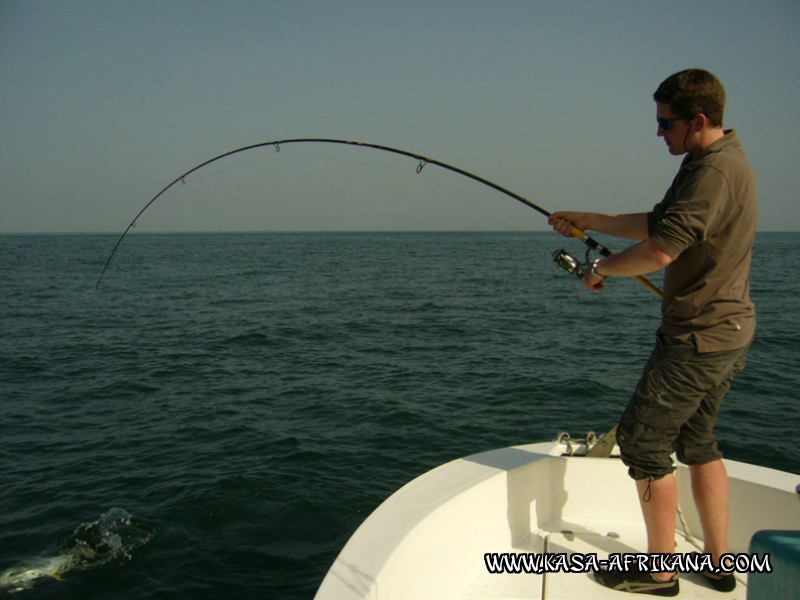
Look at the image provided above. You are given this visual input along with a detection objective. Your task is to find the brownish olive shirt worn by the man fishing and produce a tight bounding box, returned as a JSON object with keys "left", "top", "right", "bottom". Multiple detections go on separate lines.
{"left": 647, "top": 130, "right": 758, "bottom": 352}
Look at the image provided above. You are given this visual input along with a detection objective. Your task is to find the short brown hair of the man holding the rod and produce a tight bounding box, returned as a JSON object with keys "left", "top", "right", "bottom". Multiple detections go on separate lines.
{"left": 653, "top": 69, "right": 725, "bottom": 127}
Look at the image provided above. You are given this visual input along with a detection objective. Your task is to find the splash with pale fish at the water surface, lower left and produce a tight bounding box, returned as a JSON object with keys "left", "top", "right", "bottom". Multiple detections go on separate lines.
{"left": 0, "top": 508, "right": 156, "bottom": 594}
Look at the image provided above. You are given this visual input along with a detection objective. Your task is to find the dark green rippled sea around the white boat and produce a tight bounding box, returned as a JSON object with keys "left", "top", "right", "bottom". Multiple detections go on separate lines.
{"left": 0, "top": 232, "right": 800, "bottom": 600}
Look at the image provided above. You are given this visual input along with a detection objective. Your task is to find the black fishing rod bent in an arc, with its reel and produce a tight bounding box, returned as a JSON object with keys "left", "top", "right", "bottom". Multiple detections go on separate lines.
{"left": 95, "top": 138, "right": 662, "bottom": 297}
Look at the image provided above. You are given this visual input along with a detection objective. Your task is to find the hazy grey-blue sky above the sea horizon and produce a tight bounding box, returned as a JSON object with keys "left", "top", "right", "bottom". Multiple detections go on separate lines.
{"left": 0, "top": 0, "right": 800, "bottom": 233}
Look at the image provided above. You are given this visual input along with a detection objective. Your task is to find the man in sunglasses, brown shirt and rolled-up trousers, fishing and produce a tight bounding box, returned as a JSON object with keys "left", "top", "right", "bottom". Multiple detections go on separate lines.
{"left": 549, "top": 69, "right": 757, "bottom": 596}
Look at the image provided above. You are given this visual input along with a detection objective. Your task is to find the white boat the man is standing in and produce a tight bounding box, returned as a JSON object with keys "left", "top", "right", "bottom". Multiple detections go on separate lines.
{"left": 315, "top": 434, "right": 800, "bottom": 600}
